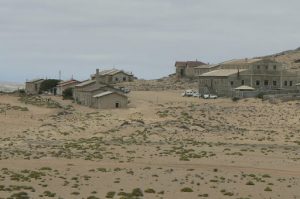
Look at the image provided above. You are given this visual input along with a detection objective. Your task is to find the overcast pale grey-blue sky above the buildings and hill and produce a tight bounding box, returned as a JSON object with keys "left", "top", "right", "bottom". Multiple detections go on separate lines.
{"left": 0, "top": 0, "right": 300, "bottom": 82}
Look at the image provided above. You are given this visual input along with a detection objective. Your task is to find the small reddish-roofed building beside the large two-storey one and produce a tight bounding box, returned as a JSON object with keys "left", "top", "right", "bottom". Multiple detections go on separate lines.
{"left": 175, "top": 60, "right": 207, "bottom": 78}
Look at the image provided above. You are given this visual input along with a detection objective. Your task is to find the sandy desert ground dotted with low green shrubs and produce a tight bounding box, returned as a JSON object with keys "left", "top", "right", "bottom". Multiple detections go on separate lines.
{"left": 0, "top": 91, "right": 300, "bottom": 199}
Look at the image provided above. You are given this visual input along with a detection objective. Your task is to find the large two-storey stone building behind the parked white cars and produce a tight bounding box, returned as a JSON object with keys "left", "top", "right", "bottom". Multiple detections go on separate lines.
{"left": 198, "top": 59, "right": 300, "bottom": 96}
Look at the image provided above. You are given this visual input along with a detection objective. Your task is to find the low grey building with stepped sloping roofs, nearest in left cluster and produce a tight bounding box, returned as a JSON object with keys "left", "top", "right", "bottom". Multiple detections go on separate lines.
{"left": 73, "top": 69, "right": 128, "bottom": 108}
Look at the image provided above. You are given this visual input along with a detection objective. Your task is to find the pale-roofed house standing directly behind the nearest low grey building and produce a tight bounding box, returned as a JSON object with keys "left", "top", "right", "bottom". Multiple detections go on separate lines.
{"left": 91, "top": 69, "right": 134, "bottom": 84}
